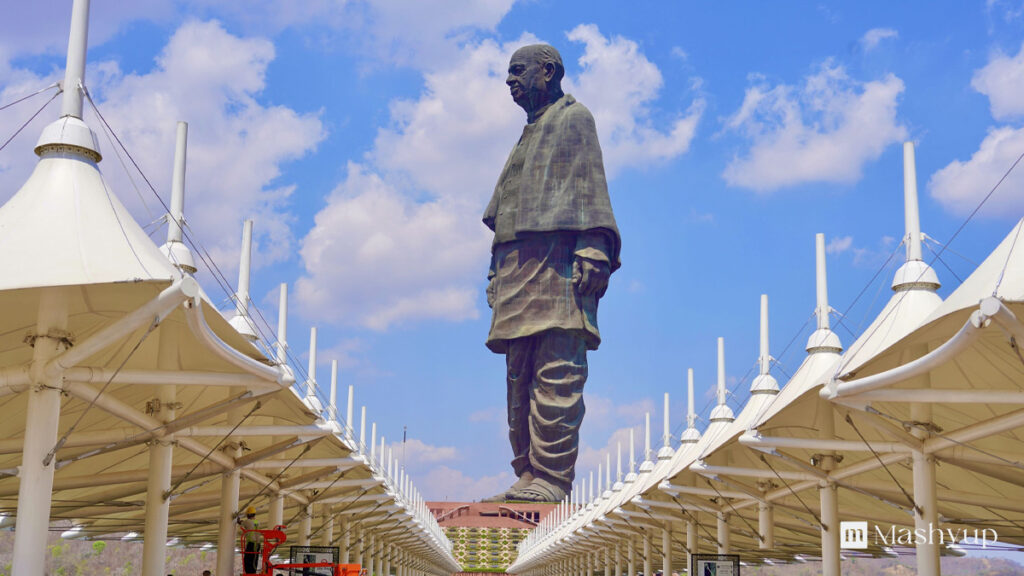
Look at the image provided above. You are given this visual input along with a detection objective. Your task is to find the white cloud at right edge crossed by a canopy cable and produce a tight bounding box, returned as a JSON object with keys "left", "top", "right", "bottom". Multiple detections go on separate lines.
{"left": 928, "top": 126, "right": 1024, "bottom": 218}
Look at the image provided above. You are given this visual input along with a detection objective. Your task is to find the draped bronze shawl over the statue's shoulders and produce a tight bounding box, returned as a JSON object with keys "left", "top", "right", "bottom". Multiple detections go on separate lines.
{"left": 483, "top": 94, "right": 622, "bottom": 270}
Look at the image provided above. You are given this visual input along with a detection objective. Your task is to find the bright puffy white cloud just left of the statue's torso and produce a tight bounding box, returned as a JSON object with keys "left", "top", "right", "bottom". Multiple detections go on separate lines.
{"left": 296, "top": 158, "right": 487, "bottom": 330}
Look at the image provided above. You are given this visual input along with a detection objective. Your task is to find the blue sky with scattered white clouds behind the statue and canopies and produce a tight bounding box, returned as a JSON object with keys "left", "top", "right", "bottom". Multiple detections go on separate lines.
{"left": 0, "top": 0, "right": 1024, "bottom": 506}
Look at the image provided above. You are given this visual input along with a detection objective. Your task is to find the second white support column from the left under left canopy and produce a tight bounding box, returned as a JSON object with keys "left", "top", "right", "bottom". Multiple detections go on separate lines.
{"left": 142, "top": 322, "right": 178, "bottom": 576}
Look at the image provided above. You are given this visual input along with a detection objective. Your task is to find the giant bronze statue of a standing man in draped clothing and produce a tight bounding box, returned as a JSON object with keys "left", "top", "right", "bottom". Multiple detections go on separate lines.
{"left": 483, "top": 44, "right": 621, "bottom": 502}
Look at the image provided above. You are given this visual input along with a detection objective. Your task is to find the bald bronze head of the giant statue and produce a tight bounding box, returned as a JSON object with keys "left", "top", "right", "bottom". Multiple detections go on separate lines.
{"left": 505, "top": 44, "right": 565, "bottom": 121}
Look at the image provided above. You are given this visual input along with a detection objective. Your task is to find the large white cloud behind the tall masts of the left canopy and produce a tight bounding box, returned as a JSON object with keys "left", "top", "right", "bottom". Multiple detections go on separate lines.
{"left": 0, "top": 22, "right": 325, "bottom": 280}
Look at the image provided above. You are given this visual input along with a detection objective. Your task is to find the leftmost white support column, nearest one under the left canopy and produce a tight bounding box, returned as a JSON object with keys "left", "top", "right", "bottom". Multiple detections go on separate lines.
{"left": 12, "top": 286, "right": 70, "bottom": 576}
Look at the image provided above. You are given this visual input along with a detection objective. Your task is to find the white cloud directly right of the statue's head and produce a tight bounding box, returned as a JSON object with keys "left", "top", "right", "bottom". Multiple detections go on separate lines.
{"left": 564, "top": 25, "right": 705, "bottom": 178}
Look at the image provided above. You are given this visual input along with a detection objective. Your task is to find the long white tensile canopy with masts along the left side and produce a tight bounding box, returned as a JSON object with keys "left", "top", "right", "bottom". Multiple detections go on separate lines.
{"left": 0, "top": 0, "right": 459, "bottom": 576}
